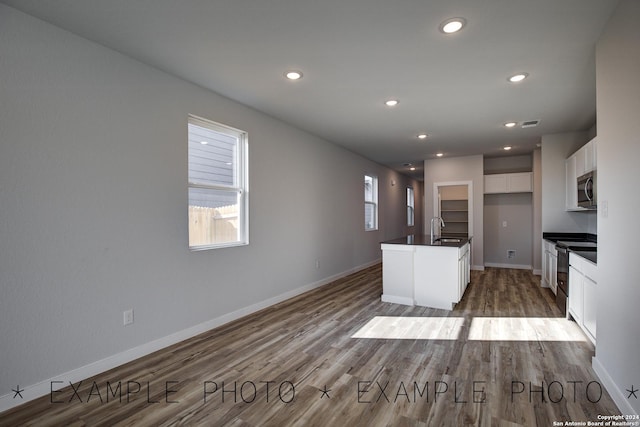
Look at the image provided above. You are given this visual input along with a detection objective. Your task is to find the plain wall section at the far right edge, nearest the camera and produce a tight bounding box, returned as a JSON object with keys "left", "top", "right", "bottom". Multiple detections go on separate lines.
{"left": 594, "top": 0, "right": 640, "bottom": 414}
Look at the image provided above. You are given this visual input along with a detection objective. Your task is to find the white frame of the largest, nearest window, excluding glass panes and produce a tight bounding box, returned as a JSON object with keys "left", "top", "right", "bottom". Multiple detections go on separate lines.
{"left": 187, "top": 114, "right": 249, "bottom": 251}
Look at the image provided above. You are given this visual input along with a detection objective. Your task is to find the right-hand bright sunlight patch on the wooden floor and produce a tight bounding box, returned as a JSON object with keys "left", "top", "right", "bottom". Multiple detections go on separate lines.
{"left": 469, "top": 317, "right": 586, "bottom": 341}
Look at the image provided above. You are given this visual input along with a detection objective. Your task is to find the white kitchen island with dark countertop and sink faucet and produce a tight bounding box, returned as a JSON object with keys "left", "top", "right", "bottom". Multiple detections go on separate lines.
{"left": 380, "top": 235, "right": 471, "bottom": 310}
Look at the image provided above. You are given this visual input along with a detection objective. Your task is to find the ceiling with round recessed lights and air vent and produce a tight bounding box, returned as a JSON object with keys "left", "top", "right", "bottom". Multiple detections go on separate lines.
{"left": 0, "top": 0, "right": 618, "bottom": 178}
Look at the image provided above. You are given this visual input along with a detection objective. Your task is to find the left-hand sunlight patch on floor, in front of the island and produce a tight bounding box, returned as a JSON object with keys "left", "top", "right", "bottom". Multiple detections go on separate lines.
{"left": 351, "top": 316, "right": 464, "bottom": 340}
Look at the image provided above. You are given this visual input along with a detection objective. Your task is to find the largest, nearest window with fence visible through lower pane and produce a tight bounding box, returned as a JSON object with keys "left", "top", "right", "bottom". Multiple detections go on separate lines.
{"left": 188, "top": 116, "right": 249, "bottom": 250}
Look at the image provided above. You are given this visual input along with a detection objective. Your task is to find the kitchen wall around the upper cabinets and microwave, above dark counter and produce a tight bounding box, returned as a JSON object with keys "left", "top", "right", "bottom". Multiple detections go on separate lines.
{"left": 541, "top": 131, "right": 600, "bottom": 234}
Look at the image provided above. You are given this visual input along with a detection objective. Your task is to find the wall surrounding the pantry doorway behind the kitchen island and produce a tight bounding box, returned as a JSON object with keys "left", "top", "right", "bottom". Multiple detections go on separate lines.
{"left": 424, "top": 156, "right": 484, "bottom": 269}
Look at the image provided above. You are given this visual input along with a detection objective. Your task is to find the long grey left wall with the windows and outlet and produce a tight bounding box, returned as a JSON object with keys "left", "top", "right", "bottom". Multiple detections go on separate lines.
{"left": 0, "top": 5, "right": 422, "bottom": 410}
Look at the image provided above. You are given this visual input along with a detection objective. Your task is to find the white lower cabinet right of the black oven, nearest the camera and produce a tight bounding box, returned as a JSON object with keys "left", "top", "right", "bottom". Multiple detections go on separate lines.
{"left": 569, "top": 253, "right": 598, "bottom": 343}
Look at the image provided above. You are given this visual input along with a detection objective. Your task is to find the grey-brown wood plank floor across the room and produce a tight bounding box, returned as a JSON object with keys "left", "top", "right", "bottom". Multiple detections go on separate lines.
{"left": 0, "top": 265, "right": 618, "bottom": 426}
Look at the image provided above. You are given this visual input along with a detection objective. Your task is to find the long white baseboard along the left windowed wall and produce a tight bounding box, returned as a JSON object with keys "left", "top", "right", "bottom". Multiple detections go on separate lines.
{"left": 0, "top": 259, "right": 382, "bottom": 413}
